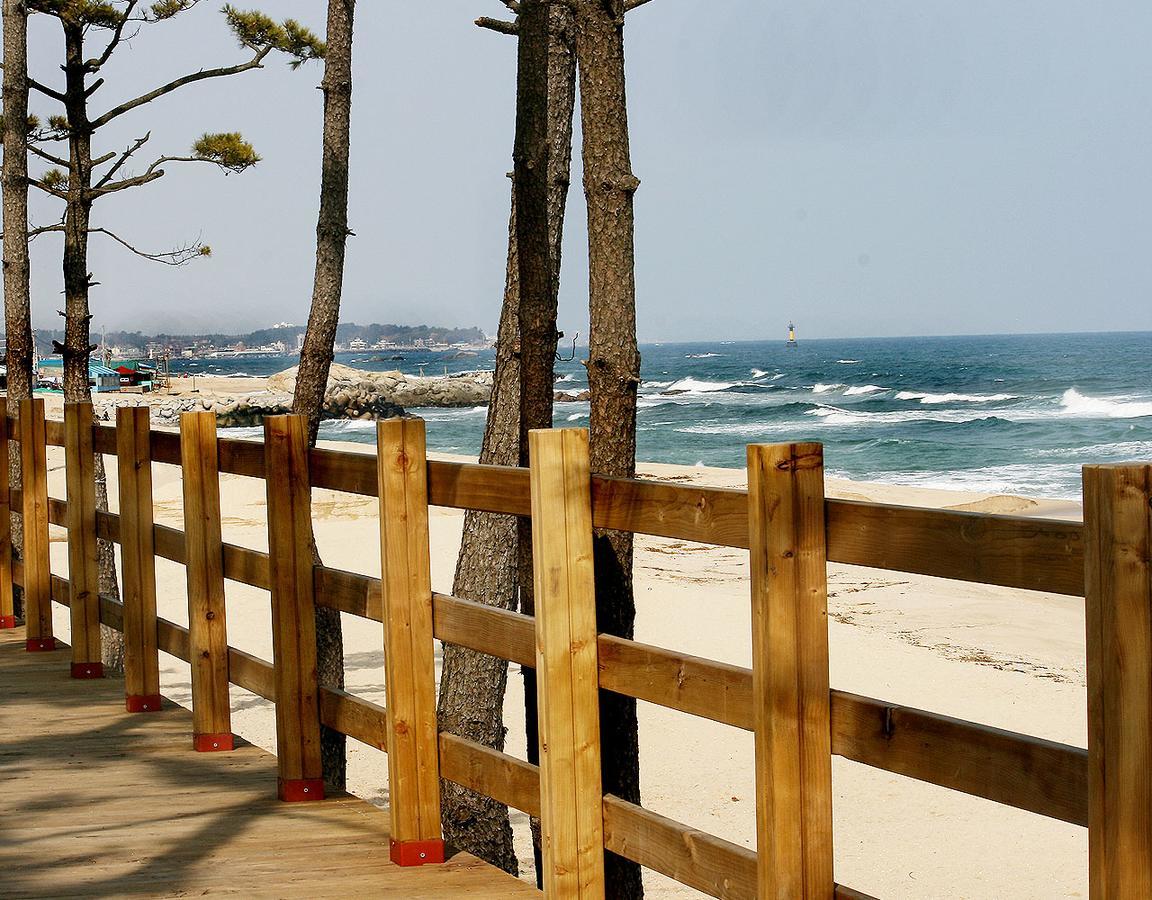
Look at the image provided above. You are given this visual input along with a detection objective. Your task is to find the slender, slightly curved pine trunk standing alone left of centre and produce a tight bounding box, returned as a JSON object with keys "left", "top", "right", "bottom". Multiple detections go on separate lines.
{"left": 293, "top": 0, "right": 356, "bottom": 788}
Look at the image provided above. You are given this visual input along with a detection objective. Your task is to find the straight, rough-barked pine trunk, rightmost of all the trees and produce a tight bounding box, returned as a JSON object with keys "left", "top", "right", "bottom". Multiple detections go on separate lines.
{"left": 575, "top": 0, "right": 643, "bottom": 898}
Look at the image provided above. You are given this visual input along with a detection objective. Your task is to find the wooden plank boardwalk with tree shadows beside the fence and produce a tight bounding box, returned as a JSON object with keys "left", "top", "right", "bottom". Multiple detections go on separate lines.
{"left": 0, "top": 628, "right": 536, "bottom": 900}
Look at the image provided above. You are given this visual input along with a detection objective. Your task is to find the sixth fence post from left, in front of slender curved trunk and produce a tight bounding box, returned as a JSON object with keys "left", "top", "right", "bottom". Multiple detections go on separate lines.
{"left": 264, "top": 416, "right": 324, "bottom": 801}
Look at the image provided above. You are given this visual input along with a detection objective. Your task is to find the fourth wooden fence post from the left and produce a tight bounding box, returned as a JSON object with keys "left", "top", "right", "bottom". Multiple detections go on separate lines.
{"left": 116, "top": 407, "right": 160, "bottom": 712}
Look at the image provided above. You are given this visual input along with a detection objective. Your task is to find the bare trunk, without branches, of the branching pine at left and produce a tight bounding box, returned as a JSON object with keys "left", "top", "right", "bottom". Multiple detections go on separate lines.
{"left": 58, "top": 22, "right": 124, "bottom": 674}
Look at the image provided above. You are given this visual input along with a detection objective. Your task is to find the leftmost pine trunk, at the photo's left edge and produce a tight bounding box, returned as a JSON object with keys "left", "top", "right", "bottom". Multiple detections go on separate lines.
{"left": 2, "top": 0, "right": 32, "bottom": 618}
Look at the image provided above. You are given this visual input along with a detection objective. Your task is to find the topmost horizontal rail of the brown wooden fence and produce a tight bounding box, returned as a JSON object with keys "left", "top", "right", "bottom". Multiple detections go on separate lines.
{"left": 24, "top": 412, "right": 1084, "bottom": 597}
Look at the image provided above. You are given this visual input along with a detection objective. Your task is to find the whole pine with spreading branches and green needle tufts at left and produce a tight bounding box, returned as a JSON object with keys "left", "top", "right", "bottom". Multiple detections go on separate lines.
{"left": 25, "top": 0, "right": 325, "bottom": 671}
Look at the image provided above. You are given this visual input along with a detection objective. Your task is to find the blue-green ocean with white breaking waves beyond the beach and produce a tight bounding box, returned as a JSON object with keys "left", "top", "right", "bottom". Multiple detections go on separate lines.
{"left": 173, "top": 332, "right": 1152, "bottom": 498}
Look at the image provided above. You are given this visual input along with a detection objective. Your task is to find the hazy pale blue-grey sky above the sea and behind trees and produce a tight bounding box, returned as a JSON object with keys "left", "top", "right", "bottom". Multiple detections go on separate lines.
{"left": 22, "top": 0, "right": 1152, "bottom": 340}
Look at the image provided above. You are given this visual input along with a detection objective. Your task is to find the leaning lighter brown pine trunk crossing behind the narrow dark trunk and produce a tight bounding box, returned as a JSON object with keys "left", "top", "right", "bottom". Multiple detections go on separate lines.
{"left": 439, "top": 3, "right": 576, "bottom": 872}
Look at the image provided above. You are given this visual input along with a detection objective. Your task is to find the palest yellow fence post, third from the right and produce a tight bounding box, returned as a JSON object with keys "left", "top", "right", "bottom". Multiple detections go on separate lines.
{"left": 529, "top": 429, "right": 605, "bottom": 898}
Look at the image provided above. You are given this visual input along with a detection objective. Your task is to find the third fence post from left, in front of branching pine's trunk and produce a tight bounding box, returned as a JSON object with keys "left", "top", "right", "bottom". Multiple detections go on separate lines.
{"left": 65, "top": 403, "right": 104, "bottom": 678}
